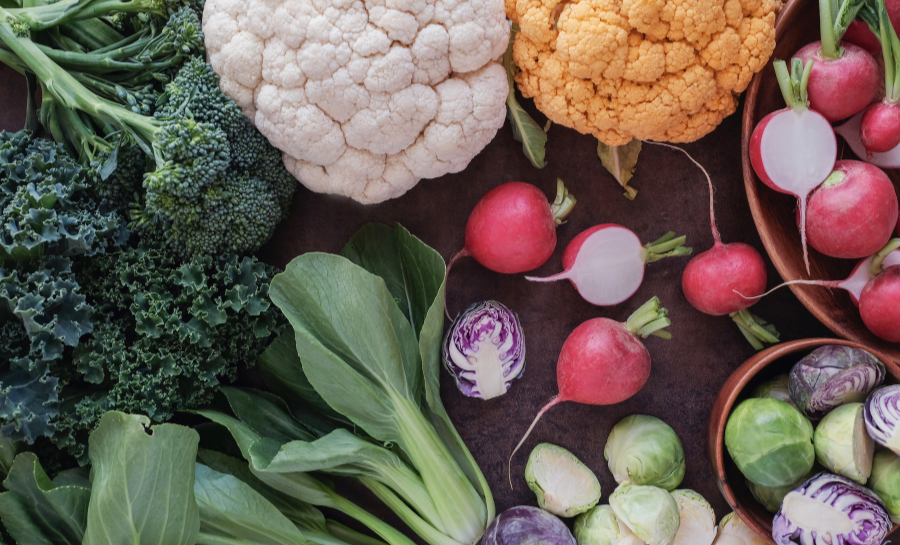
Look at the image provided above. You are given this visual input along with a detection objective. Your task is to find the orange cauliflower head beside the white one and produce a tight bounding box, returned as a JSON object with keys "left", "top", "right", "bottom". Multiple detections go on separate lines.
{"left": 505, "top": 0, "right": 782, "bottom": 146}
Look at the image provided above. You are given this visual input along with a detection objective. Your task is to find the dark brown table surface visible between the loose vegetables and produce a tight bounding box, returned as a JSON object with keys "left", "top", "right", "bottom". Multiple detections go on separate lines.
{"left": 0, "top": 65, "right": 833, "bottom": 528}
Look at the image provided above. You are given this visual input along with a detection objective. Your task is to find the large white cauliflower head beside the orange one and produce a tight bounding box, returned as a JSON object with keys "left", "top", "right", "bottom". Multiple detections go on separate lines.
{"left": 203, "top": 0, "right": 509, "bottom": 203}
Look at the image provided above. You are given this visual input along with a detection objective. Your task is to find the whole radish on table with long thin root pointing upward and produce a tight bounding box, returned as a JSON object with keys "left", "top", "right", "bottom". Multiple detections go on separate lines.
{"left": 651, "top": 142, "right": 778, "bottom": 350}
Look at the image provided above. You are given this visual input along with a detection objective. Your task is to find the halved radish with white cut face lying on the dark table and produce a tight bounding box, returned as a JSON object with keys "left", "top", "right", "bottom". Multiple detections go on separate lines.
{"left": 525, "top": 223, "right": 691, "bottom": 307}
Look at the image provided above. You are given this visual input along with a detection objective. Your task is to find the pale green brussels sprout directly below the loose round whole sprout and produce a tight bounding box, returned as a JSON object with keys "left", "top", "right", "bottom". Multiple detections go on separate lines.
{"left": 609, "top": 484, "right": 679, "bottom": 545}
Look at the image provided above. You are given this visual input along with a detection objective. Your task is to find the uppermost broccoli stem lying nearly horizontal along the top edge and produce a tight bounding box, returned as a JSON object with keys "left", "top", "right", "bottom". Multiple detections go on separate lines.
{"left": 5, "top": 0, "right": 167, "bottom": 30}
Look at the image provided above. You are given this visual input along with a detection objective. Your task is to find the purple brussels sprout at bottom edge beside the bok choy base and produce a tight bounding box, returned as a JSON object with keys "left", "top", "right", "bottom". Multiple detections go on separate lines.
{"left": 480, "top": 505, "right": 576, "bottom": 545}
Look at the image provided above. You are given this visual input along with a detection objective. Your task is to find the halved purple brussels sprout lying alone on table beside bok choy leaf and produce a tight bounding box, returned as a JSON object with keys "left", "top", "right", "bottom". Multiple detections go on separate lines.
{"left": 443, "top": 301, "right": 525, "bottom": 399}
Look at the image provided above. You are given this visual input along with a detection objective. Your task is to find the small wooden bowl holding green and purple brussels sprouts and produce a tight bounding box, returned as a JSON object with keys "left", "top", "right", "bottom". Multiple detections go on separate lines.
{"left": 708, "top": 339, "right": 900, "bottom": 541}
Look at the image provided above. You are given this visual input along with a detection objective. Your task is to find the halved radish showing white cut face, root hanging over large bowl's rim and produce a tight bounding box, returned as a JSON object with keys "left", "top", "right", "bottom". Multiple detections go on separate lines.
{"left": 750, "top": 59, "right": 837, "bottom": 273}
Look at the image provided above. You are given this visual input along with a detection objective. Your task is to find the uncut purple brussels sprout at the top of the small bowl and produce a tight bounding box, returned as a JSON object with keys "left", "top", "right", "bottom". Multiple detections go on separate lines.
{"left": 789, "top": 345, "right": 884, "bottom": 420}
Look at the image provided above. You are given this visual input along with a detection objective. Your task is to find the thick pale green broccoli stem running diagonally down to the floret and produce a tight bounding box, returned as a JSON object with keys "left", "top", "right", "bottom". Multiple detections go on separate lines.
{"left": 0, "top": 4, "right": 160, "bottom": 151}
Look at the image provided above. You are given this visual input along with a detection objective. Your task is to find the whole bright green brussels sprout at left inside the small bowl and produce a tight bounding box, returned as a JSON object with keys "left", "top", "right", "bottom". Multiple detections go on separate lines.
{"left": 725, "top": 398, "right": 816, "bottom": 487}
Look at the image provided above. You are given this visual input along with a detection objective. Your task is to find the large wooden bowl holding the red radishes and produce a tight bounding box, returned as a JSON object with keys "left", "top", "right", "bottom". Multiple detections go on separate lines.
{"left": 741, "top": 0, "right": 900, "bottom": 370}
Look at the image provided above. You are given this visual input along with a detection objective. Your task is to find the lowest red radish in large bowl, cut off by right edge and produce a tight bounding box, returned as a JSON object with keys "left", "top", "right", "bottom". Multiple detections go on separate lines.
{"left": 859, "top": 238, "right": 900, "bottom": 343}
